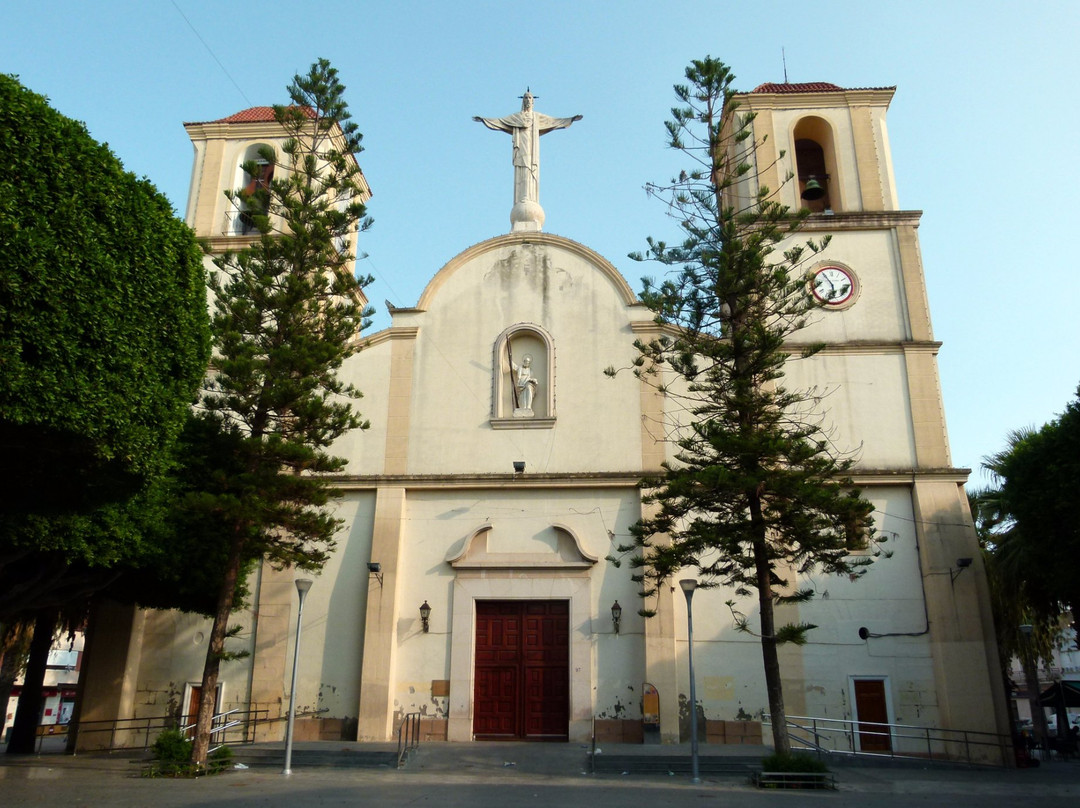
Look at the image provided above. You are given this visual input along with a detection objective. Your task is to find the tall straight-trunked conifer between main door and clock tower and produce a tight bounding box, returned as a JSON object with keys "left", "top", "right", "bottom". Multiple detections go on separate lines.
{"left": 620, "top": 58, "right": 873, "bottom": 753}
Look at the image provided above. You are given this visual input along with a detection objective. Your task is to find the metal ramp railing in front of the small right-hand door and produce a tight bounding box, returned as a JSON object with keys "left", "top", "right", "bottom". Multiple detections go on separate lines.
{"left": 762, "top": 715, "right": 1013, "bottom": 766}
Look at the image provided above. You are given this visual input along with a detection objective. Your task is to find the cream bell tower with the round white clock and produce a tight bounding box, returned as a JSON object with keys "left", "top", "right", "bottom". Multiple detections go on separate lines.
{"left": 737, "top": 82, "right": 1009, "bottom": 733}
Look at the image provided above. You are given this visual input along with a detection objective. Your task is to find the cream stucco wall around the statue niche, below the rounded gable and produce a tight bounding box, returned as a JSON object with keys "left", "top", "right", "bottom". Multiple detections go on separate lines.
{"left": 350, "top": 243, "right": 642, "bottom": 474}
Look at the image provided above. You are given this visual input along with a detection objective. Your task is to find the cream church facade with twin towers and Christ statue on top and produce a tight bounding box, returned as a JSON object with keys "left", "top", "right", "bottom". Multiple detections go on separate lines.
{"left": 76, "top": 84, "right": 1009, "bottom": 762}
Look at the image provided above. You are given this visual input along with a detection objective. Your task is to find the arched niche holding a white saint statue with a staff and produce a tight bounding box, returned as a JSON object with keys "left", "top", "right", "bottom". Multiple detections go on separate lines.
{"left": 491, "top": 323, "right": 555, "bottom": 429}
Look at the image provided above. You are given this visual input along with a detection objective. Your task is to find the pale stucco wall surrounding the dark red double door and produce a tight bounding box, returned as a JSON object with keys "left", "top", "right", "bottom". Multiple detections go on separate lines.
{"left": 384, "top": 488, "right": 645, "bottom": 717}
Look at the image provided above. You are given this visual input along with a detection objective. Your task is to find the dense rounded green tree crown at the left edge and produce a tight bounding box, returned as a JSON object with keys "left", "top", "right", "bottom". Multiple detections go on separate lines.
{"left": 0, "top": 76, "right": 208, "bottom": 512}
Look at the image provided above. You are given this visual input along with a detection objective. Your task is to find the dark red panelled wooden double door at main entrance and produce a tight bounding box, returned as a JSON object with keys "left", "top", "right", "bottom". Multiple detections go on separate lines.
{"left": 473, "top": 601, "right": 570, "bottom": 741}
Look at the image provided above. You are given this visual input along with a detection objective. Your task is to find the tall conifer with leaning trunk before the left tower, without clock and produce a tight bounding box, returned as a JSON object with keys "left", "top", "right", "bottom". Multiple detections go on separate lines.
{"left": 193, "top": 59, "right": 369, "bottom": 765}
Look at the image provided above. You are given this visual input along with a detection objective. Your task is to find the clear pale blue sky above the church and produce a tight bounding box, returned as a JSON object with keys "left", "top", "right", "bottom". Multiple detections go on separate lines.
{"left": 8, "top": 0, "right": 1080, "bottom": 486}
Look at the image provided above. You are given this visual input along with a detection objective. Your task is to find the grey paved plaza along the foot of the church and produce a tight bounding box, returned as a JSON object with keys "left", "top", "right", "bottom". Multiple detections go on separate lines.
{"left": 0, "top": 743, "right": 1080, "bottom": 808}
